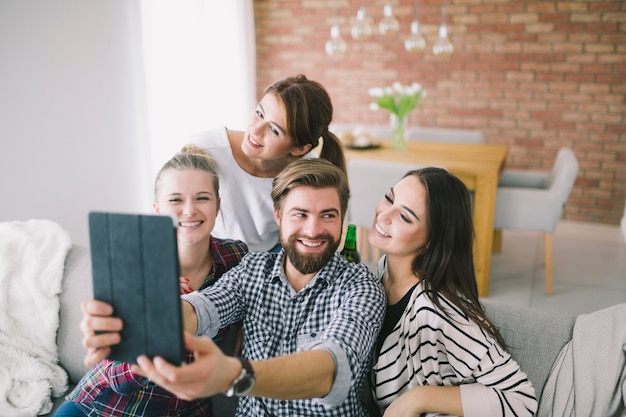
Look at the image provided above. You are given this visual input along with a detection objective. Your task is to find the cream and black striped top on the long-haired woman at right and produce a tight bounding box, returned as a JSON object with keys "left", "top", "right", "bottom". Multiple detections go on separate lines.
{"left": 372, "top": 255, "right": 537, "bottom": 417}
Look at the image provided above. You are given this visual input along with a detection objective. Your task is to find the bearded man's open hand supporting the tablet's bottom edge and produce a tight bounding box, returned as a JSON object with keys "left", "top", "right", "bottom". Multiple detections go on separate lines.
{"left": 132, "top": 333, "right": 241, "bottom": 400}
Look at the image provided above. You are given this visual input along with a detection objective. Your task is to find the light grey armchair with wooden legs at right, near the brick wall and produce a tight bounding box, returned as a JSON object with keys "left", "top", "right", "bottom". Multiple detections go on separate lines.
{"left": 493, "top": 148, "right": 578, "bottom": 294}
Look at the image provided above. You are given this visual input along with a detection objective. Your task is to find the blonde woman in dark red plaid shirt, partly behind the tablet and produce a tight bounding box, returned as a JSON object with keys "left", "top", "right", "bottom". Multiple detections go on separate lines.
{"left": 54, "top": 145, "right": 248, "bottom": 417}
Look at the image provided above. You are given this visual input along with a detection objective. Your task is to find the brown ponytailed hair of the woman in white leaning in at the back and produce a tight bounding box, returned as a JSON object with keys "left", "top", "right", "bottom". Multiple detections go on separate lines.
{"left": 264, "top": 74, "right": 346, "bottom": 173}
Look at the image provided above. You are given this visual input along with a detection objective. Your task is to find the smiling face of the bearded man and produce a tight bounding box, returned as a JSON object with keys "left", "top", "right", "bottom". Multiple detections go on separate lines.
{"left": 274, "top": 186, "right": 343, "bottom": 275}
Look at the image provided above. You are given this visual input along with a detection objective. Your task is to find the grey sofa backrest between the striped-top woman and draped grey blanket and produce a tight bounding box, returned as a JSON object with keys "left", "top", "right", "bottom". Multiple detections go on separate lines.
{"left": 481, "top": 300, "right": 576, "bottom": 400}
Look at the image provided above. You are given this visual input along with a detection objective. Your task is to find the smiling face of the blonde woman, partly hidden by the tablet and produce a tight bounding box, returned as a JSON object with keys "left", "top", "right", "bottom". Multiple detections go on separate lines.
{"left": 154, "top": 169, "right": 219, "bottom": 245}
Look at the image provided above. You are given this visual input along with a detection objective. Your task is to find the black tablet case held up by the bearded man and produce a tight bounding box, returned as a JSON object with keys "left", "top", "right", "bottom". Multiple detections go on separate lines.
{"left": 89, "top": 212, "right": 184, "bottom": 364}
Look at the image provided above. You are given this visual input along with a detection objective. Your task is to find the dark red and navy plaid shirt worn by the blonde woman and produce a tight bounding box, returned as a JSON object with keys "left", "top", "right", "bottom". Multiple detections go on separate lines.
{"left": 66, "top": 236, "right": 248, "bottom": 417}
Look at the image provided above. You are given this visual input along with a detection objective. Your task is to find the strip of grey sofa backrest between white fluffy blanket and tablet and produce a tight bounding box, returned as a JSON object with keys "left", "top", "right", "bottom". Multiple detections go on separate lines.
{"left": 57, "top": 245, "right": 93, "bottom": 385}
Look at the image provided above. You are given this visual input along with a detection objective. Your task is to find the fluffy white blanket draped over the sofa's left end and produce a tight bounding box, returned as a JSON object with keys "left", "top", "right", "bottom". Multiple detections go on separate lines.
{"left": 0, "top": 220, "right": 71, "bottom": 417}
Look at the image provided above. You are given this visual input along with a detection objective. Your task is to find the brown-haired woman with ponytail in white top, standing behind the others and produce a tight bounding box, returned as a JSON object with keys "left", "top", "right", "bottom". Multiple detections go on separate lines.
{"left": 192, "top": 74, "right": 346, "bottom": 251}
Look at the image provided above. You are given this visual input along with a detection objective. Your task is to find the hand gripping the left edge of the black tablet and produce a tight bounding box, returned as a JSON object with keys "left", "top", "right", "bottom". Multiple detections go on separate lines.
{"left": 80, "top": 300, "right": 123, "bottom": 366}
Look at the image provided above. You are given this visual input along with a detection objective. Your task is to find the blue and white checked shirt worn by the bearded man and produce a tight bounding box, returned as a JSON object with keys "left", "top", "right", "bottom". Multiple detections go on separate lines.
{"left": 183, "top": 250, "right": 386, "bottom": 417}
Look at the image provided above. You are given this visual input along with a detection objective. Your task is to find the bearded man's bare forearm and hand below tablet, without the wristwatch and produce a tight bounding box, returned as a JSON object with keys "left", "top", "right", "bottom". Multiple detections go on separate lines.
{"left": 133, "top": 334, "right": 335, "bottom": 400}
